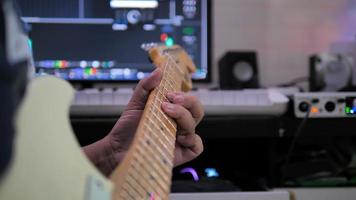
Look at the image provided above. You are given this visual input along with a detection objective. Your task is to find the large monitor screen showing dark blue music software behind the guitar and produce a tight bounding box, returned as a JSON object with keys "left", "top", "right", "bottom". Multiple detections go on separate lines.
{"left": 18, "top": 0, "right": 211, "bottom": 82}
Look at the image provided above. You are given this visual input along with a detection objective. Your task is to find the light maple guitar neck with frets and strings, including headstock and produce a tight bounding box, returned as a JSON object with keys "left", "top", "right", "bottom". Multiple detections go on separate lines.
{"left": 111, "top": 46, "right": 195, "bottom": 200}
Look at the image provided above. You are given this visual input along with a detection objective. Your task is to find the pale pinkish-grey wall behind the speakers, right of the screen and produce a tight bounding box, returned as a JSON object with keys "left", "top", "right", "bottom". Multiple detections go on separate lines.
{"left": 213, "top": 0, "right": 356, "bottom": 86}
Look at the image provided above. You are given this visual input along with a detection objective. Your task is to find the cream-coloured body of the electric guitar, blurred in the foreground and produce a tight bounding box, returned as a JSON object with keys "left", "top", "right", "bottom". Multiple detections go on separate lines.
{"left": 0, "top": 77, "right": 112, "bottom": 200}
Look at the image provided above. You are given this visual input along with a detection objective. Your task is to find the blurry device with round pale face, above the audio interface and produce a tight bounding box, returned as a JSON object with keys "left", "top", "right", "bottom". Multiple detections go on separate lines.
{"left": 309, "top": 53, "right": 354, "bottom": 91}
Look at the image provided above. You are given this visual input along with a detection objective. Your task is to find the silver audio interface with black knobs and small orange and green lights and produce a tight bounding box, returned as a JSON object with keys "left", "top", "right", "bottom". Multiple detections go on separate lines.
{"left": 294, "top": 92, "right": 356, "bottom": 118}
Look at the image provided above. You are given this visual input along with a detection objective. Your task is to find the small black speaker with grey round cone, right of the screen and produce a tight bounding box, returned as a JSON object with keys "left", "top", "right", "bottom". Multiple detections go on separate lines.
{"left": 219, "top": 51, "right": 259, "bottom": 89}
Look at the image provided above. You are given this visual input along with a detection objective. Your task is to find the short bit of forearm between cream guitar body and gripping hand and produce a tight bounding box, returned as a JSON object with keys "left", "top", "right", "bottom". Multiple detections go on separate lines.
{"left": 83, "top": 137, "right": 118, "bottom": 176}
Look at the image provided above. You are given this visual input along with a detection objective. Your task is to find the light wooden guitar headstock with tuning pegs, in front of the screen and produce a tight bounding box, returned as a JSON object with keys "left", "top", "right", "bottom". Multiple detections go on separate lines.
{"left": 145, "top": 44, "right": 196, "bottom": 91}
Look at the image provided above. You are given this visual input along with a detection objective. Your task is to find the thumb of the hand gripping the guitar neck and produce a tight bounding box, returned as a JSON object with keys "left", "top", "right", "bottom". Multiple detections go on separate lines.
{"left": 126, "top": 69, "right": 162, "bottom": 110}
